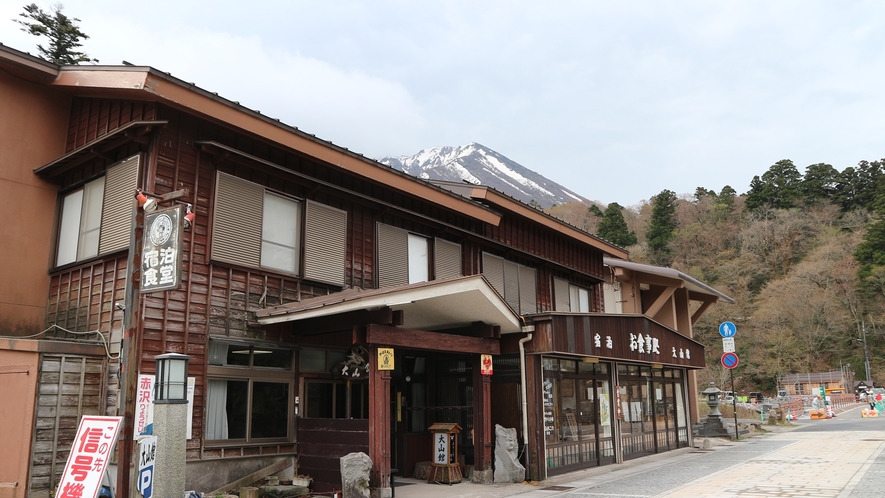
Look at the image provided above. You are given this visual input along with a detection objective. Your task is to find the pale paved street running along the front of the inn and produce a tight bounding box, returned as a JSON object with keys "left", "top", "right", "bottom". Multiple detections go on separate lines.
{"left": 395, "top": 410, "right": 885, "bottom": 498}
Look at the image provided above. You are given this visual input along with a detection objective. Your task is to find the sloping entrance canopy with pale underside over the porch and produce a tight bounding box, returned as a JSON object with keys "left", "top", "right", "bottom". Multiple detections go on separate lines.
{"left": 255, "top": 275, "right": 522, "bottom": 334}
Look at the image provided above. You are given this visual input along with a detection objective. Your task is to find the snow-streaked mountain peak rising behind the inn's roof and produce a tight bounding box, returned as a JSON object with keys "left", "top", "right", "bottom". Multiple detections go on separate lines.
{"left": 379, "top": 143, "right": 590, "bottom": 208}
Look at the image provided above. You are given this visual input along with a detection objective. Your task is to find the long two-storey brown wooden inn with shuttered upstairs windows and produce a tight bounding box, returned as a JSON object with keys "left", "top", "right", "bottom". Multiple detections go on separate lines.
{"left": 0, "top": 46, "right": 733, "bottom": 497}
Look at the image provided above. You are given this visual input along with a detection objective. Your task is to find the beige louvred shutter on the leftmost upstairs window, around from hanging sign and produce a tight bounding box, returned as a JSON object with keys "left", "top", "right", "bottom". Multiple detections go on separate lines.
{"left": 98, "top": 155, "right": 141, "bottom": 254}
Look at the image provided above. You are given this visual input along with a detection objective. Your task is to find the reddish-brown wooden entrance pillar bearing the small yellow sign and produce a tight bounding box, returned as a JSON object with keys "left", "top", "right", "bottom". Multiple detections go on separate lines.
{"left": 369, "top": 344, "right": 390, "bottom": 496}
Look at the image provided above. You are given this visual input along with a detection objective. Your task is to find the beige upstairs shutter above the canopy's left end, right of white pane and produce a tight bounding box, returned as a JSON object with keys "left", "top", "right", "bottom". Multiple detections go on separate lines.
{"left": 304, "top": 201, "right": 347, "bottom": 287}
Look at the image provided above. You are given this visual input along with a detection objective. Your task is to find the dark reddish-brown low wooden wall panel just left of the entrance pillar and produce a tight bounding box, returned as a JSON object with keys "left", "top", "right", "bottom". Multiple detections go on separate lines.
{"left": 297, "top": 418, "right": 369, "bottom": 492}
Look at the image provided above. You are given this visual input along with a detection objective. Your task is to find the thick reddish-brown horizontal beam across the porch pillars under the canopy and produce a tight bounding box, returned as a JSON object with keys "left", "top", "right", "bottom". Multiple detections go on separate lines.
{"left": 366, "top": 324, "right": 501, "bottom": 354}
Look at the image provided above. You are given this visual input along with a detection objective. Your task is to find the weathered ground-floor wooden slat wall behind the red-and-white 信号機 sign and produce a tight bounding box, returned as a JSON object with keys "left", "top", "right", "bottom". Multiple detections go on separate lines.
{"left": 29, "top": 355, "right": 107, "bottom": 496}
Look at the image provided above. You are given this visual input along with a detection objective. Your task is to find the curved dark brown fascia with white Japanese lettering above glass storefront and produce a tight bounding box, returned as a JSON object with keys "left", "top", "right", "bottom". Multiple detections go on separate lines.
{"left": 528, "top": 314, "right": 705, "bottom": 368}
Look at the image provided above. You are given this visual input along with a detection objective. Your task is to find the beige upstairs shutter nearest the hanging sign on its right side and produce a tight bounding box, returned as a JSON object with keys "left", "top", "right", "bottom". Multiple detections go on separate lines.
{"left": 212, "top": 172, "right": 264, "bottom": 268}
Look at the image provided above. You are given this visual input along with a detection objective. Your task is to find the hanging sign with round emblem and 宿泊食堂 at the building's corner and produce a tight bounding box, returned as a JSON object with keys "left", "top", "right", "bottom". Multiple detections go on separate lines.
{"left": 141, "top": 206, "right": 181, "bottom": 292}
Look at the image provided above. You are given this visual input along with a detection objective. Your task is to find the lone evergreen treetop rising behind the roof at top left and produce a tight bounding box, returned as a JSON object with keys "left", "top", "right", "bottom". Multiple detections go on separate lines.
{"left": 13, "top": 3, "right": 98, "bottom": 65}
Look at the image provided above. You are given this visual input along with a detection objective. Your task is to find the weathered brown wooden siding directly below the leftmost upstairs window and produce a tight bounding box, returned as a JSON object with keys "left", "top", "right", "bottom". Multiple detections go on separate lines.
{"left": 46, "top": 253, "right": 127, "bottom": 340}
